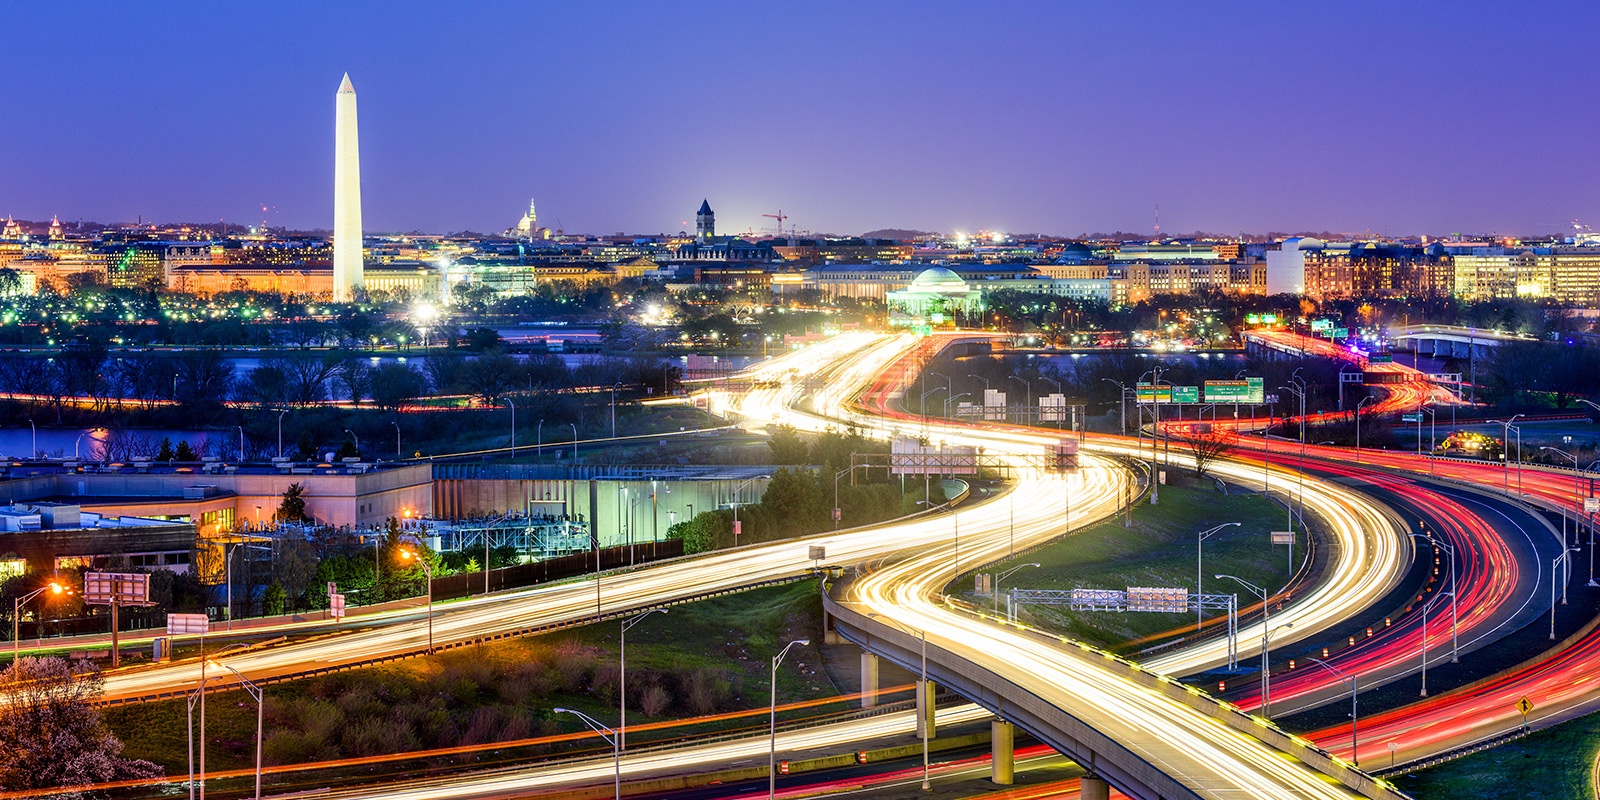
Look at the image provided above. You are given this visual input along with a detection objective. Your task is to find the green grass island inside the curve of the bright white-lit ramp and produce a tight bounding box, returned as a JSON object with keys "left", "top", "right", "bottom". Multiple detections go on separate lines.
{"left": 963, "top": 474, "right": 1306, "bottom": 648}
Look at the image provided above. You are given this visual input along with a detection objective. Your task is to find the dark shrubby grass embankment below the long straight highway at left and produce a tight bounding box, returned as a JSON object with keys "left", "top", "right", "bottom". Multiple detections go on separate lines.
{"left": 106, "top": 582, "right": 834, "bottom": 774}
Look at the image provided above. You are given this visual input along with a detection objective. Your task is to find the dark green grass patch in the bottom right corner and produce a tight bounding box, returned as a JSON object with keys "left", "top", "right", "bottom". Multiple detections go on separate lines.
{"left": 1378, "top": 715, "right": 1600, "bottom": 800}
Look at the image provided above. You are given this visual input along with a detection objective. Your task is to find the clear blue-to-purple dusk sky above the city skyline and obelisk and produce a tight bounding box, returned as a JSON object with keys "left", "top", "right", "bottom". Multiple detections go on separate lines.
{"left": 0, "top": 0, "right": 1600, "bottom": 235}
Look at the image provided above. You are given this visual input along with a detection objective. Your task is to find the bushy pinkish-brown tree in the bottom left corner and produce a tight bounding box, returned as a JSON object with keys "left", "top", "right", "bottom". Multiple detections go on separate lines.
{"left": 0, "top": 658, "right": 162, "bottom": 797}
